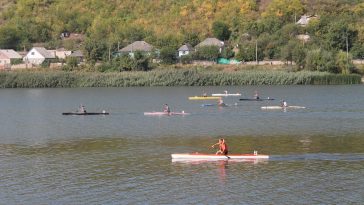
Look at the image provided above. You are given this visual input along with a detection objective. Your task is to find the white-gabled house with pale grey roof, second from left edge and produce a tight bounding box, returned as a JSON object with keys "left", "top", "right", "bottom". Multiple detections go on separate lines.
{"left": 23, "top": 47, "right": 56, "bottom": 65}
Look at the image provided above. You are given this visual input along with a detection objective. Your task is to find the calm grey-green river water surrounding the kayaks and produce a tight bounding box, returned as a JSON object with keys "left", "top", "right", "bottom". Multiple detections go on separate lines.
{"left": 0, "top": 85, "right": 364, "bottom": 204}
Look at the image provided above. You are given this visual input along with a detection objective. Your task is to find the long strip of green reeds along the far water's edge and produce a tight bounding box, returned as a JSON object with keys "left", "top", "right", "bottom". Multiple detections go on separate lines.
{"left": 0, "top": 69, "right": 362, "bottom": 88}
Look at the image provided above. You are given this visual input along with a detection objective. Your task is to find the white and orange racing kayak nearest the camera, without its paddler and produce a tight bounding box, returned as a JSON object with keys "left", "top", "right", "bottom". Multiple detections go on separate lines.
{"left": 171, "top": 153, "right": 269, "bottom": 160}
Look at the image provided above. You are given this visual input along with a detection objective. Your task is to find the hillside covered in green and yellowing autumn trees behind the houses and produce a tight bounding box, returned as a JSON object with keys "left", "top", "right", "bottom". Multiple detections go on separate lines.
{"left": 0, "top": 0, "right": 364, "bottom": 73}
